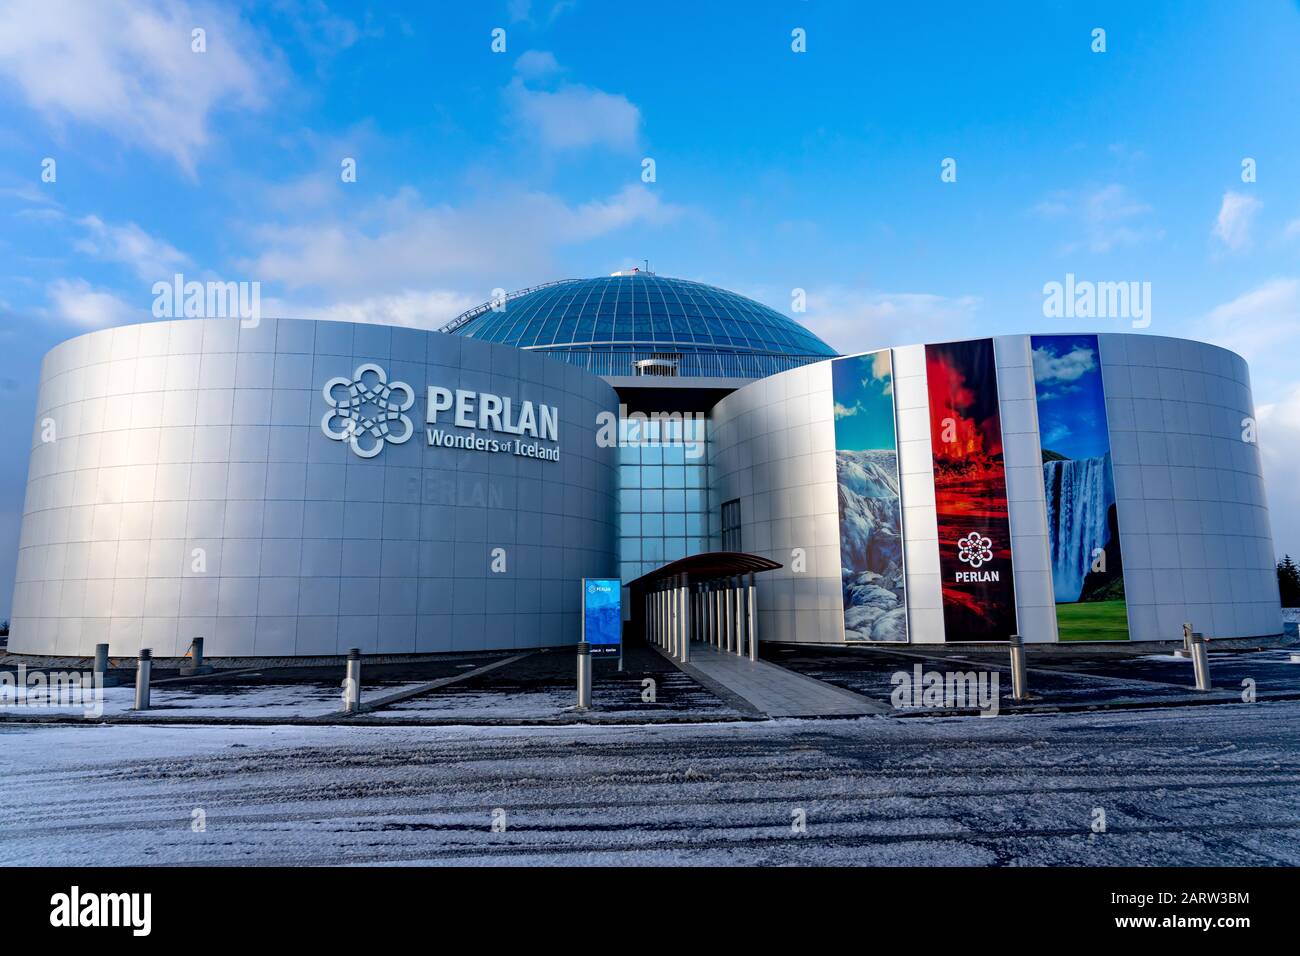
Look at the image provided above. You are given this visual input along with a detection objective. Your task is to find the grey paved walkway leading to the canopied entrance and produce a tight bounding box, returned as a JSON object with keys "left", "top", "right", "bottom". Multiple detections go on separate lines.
{"left": 677, "top": 641, "right": 891, "bottom": 717}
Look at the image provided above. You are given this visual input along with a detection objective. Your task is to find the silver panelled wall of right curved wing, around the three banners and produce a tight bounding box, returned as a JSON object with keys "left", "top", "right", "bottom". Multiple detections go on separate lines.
{"left": 712, "top": 334, "right": 1282, "bottom": 643}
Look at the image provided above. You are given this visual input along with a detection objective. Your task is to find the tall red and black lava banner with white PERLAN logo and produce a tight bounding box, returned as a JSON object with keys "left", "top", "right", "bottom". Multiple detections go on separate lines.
{"left": 926, "top": 338, "right": 1015, "bottom": 641}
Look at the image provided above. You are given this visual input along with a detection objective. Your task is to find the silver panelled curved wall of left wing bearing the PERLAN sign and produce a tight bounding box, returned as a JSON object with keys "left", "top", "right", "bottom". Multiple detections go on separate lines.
{"left": 9, "top": 319, "right": 618, "bottom": 657}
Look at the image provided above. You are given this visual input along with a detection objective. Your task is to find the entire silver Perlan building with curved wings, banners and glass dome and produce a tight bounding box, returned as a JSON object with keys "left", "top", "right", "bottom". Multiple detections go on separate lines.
{"left": 9, "top": 271, "right": 1282, "bottom": 657}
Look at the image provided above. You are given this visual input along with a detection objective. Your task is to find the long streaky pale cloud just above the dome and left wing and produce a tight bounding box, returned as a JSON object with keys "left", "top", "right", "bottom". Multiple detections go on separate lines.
{"left": 242, "top": 185, "right": 683, "bottom": 293}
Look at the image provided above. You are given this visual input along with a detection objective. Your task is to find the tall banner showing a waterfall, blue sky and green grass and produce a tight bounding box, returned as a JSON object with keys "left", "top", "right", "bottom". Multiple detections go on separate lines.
{"left": 1030, "top": 336, "right": 1128, "bottom": 641}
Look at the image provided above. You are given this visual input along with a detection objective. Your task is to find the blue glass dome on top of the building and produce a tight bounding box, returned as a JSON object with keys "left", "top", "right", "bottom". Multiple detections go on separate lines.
{"left": 442, "top": 269, "right": 836, "bottom": 378}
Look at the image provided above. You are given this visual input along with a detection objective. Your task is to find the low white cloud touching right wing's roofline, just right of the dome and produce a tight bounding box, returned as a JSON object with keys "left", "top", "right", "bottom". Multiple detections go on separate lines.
{"left": 794, "top": 287, "right": 979, "bottom": 355}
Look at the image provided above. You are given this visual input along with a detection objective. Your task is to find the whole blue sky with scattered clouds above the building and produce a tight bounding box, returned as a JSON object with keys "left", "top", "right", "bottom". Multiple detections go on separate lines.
{"left": 0, "top": 0, "right": 1300, "bottom": 617}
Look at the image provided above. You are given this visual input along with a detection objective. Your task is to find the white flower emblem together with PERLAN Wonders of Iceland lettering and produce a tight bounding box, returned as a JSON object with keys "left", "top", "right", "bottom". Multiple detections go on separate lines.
{"left": 321, "top": 363, "right": 560, "bottom": 462}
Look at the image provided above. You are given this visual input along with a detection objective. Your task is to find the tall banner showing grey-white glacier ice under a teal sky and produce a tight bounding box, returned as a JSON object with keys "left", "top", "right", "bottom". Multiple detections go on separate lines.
{"left": 831, "top": 349, "right": 907, "bottom": 641}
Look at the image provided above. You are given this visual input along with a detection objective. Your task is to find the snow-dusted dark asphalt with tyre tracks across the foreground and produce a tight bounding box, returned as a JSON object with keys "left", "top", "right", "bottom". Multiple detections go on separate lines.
{"left": 0, "top": 702, "right": 1300, "bottom": 865}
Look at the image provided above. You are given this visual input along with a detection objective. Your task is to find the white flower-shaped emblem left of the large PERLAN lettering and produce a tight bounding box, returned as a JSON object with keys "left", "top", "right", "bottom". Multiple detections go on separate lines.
{"left": 321, "top": 362, "right": 415, "bottom": 458}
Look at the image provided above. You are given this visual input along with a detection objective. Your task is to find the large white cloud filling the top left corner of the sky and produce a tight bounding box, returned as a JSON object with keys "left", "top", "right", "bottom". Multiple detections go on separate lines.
{"left": 0, "top": 0, "right": 274, "bottom": 176}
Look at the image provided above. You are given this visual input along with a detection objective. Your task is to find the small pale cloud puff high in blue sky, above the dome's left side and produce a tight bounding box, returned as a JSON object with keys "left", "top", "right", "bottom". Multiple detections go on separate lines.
{"left": 506, "top": 77, "right": 641, "bottom": 151}
